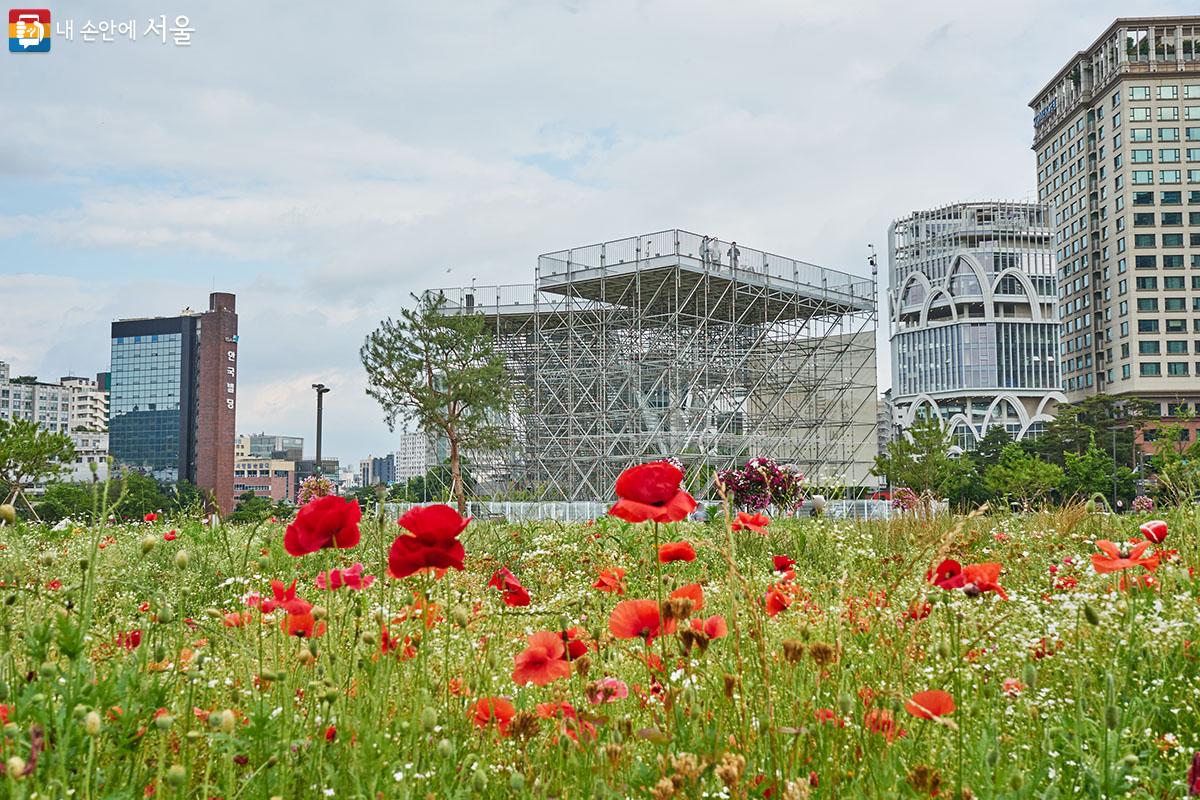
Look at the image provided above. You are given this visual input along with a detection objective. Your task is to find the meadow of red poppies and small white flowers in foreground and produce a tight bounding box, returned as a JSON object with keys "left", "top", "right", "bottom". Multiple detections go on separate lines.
{"left": 0, "top": 468, "right": 1200, "bottom": 800}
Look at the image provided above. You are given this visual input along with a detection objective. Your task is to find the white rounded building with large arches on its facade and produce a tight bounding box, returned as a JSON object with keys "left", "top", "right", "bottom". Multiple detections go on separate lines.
{"left": 888, "top": 201, "right": 1066, "bottom": 450}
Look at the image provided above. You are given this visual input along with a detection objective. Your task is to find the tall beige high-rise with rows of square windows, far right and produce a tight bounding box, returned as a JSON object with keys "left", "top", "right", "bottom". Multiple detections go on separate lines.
{"left": 1030, "top": 17, "right": 1200, "bottom": 438}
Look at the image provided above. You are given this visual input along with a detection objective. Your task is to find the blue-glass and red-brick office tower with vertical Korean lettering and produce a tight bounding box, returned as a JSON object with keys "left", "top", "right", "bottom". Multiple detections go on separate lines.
{"left": 108, "top": 293, "right": 238, "bottom": 513}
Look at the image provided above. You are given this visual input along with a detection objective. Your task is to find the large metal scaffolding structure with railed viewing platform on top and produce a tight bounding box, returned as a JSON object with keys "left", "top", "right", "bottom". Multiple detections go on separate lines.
{"left": 433, "top": 230, "right": 877, "bottom": 500}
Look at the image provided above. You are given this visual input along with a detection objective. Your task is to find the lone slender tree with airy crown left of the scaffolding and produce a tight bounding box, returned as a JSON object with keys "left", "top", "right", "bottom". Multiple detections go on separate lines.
{"left": 359, "top": 294, "right": 512, "bottom": 513}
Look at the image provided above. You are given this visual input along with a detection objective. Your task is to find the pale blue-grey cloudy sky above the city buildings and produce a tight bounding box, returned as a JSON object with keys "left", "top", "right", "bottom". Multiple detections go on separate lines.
{"left": 0, "top": 0, "right": 1186, "bottom": 462}
